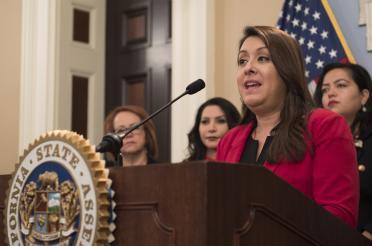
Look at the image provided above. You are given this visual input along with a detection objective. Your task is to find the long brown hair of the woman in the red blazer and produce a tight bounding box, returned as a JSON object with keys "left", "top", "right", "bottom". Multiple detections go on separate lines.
{"left": 239, "top": 26, "right": 314, "bottom": 163}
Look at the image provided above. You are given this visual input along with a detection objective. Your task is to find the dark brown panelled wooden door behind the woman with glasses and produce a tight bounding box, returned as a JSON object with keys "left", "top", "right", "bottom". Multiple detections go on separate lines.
{"left": 105, "top": 0, "right": 171, "bottom": 161}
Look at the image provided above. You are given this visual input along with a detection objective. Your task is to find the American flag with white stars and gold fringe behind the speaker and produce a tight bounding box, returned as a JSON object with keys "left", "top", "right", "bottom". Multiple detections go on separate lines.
{"left": 278, "top": 0, "right": 355, "bottom": 92}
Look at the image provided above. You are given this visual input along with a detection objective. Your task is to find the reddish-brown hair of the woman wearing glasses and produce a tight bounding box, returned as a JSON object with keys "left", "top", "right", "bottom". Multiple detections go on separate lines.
{"left": 104, "top": 105, "right": 158, "bottom": 160}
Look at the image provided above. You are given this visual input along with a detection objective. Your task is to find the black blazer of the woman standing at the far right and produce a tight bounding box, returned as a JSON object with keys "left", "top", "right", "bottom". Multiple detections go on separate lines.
{"left": 356, "top": 127, "right": 372, "bottom": 233}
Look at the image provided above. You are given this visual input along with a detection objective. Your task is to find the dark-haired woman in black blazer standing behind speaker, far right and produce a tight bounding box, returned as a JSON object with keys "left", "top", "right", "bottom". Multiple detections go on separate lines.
{"left": 314, "top": 63, "right": 372, "bottom": 241}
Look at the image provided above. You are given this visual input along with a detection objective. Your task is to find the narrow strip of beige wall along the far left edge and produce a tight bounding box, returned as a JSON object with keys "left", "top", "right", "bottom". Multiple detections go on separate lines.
{"left": 0, "top": 0, "right": 22, "bottom": 174}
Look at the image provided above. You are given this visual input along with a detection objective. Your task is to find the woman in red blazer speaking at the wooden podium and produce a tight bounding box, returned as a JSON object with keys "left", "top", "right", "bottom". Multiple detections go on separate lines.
{"left": 217, "top": 26, "right": 359, "bottom": 226}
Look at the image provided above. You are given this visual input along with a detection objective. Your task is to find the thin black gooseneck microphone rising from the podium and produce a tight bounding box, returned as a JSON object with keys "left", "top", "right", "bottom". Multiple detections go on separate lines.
{"left": 96, "top": 79, "right": 205, "bottom": 153}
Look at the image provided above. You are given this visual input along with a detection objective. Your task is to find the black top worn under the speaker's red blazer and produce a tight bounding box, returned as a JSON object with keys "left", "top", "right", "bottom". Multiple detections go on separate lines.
{"left": 240, "top": 131, "right": 273, "bottom": 166}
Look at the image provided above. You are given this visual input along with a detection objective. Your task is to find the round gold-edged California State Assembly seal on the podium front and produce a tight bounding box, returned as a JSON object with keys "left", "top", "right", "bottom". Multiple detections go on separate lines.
{"left": 4, "top": 131, "right": 110, "bottom": 245}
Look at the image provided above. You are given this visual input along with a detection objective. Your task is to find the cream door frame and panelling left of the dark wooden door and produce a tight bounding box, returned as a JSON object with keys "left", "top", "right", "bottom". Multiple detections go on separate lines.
{"left": 19, "top": 0, "right": 106, "bottom": 154}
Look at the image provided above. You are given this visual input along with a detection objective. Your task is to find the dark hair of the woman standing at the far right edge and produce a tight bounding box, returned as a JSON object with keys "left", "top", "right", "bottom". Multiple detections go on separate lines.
{"left": 314, "top": 63, "right": 372, "bottom": 136}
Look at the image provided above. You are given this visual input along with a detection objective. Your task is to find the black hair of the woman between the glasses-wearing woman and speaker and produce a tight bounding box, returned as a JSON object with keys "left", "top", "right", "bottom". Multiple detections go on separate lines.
{"left": 187, "top": 97, "right": 240, "bottom": 161}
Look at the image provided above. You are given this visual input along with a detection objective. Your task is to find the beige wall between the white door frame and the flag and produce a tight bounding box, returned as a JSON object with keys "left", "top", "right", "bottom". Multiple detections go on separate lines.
{"left": 214, "top": 0, "right": 283, "bottom": 109}
